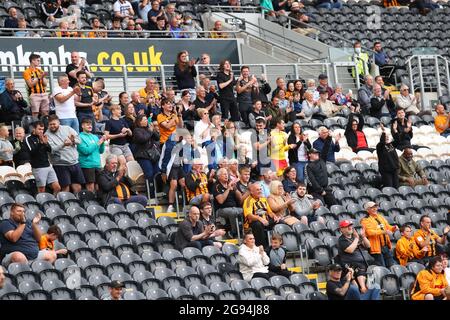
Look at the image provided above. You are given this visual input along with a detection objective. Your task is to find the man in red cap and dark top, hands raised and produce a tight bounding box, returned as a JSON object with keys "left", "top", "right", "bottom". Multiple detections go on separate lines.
{"left": 337, "top": 220, "right": 370, "bottom": 294}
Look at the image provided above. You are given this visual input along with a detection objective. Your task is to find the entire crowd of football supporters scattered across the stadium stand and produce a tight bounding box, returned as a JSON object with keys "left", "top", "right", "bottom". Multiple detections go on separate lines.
{"left": 0, "top": 0, "right": 450, "bottom": 300}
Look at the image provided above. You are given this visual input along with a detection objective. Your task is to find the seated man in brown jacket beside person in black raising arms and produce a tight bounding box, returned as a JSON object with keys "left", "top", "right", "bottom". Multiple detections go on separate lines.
{"left": 398, "top": 147, "right": 430, "bottom": 188}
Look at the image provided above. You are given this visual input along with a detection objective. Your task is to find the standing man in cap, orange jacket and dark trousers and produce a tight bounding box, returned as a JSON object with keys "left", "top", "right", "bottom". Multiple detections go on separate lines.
{"left": 361, "top": 201, "right": 398, "bottom": 268}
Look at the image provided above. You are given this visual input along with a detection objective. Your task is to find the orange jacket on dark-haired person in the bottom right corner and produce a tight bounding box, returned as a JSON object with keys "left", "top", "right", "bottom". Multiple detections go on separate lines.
{"left": 411, "top": 269, "right": 448, "bottom": 300}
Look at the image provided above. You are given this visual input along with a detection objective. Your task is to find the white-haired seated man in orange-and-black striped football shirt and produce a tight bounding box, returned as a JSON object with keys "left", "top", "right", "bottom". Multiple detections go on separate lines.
{"left": 186, "top": 158, "right": 211, "bottom": 206}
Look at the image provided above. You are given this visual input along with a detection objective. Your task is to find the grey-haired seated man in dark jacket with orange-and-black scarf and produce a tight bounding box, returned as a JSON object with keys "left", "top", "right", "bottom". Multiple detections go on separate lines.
{"left": 97, "top": 154, "right": 148, "bottom": 207}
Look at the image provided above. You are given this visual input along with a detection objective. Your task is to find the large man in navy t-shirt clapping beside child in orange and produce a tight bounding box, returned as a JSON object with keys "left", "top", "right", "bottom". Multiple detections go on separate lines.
{"left": 0, "top": 203, "right": 53, "bottom": 267}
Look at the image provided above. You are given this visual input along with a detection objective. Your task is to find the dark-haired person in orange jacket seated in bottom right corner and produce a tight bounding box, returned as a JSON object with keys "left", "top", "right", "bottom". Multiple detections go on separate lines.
{"left": 411, "top": 256, "right": 448, "bottom": 300}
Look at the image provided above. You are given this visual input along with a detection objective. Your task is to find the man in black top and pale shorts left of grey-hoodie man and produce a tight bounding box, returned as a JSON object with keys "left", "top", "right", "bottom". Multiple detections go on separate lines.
{"left": 25, "top": 121, "right": 61, "bottom": 195}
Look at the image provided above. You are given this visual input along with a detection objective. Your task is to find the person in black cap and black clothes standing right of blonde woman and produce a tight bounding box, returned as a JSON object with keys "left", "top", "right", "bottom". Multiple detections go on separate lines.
{"left": 305, "top": 148, "right": 337, "bottom": 207}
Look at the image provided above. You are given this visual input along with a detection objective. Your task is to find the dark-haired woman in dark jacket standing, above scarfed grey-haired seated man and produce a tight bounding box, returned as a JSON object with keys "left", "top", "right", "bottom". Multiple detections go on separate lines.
{"left": 133, "top": 114, "right": 159, "bottom": 197}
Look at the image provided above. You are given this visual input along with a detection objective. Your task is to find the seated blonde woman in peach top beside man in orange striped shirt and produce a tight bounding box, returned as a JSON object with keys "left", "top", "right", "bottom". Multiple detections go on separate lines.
{"left": 267, "top": 180, "right": 300, "bottom": 226}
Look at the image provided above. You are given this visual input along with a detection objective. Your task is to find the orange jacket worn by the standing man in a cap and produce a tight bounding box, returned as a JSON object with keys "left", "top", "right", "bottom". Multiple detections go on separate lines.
{"left": 361, "top": 213, "right": 395, "bottom": 254}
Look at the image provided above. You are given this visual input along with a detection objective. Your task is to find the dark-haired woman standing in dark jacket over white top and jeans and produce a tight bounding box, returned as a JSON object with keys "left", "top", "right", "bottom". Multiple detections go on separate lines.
{"left": 288, "top": 122, "right": 311, "bottom": 182}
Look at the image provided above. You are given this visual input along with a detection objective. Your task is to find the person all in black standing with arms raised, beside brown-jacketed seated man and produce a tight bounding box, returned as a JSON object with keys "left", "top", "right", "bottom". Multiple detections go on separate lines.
{"left": 377, "top": 124, "right": 400, "bottom": 189}
